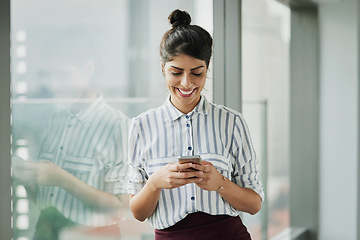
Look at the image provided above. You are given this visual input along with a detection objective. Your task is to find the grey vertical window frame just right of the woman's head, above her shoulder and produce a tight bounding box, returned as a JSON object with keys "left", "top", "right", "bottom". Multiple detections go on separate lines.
{"left": 213, "top": 0, "right": 242, "bottom": 112}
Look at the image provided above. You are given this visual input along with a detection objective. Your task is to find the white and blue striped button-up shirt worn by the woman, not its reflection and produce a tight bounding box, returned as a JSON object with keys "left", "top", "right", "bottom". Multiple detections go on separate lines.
{"left": 128, "top": 96, "right": 264, "bottom": 229}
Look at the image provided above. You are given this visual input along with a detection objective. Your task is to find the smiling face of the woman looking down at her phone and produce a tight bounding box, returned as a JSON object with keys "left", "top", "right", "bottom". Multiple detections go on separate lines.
{"left": 162, "top": 54, "right": 207, "bottom": 113}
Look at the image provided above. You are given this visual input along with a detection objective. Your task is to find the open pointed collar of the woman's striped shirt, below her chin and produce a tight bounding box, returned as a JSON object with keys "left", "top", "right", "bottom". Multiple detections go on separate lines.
{"left": 163, "top": 95, "right": 210, "bottom": 121}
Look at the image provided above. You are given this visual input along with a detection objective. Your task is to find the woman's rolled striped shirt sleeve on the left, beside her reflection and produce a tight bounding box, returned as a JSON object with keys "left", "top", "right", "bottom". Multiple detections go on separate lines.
{"left": 128, "top": 117, "right": 148, "bottom": 195}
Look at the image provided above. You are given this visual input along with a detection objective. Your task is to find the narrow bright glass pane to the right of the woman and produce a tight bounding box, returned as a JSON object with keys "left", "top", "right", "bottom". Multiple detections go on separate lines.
{"left": 242, "top": 0, "right": 290, "bottom": 239}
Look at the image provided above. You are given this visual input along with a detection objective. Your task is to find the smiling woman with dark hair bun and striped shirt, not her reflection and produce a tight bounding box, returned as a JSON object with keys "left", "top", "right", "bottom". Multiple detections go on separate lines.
{"left": 129, "top": 10, "right": 263, "bottom": 240}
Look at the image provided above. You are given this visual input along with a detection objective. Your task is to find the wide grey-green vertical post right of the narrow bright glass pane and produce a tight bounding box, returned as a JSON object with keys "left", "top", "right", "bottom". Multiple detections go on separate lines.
{"left": 289, "top": 8, "right": 320, "bottom": 239}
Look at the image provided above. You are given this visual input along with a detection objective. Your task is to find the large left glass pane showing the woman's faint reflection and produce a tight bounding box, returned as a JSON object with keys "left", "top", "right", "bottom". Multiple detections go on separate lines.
{"left": 11, "top": 0, "right": 213, "bottom": 240}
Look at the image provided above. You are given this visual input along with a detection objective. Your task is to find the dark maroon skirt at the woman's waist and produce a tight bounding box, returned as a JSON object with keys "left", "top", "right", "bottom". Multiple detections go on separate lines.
{"left": 155, "top": 212, "right": 251, "bottom": 240}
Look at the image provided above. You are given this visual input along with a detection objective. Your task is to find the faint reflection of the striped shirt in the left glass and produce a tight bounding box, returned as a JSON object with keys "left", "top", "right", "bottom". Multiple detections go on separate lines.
{"left": 37, "top": 97, "right": 128, "bottom": 226}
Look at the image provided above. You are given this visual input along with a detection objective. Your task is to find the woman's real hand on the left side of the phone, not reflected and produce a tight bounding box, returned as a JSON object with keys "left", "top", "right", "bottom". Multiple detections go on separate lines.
{"left": 148, "top": 162, "right": 203, "bottom": 189}
